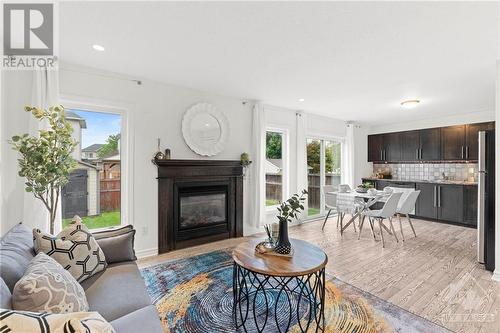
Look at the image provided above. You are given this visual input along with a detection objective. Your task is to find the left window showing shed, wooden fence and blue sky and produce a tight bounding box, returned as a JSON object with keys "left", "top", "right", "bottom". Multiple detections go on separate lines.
{"left": 61, "top": 109, "right": 122, "bottom": 229}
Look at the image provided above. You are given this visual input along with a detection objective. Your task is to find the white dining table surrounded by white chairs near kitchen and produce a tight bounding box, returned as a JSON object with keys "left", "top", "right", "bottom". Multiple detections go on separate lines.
{"left": 326, "top": 190, "right": 391, "bottom": 236}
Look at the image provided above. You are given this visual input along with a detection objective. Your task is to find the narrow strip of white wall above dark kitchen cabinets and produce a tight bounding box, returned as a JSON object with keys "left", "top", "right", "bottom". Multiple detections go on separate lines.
{"left": 370, "top": 110, "right": 495, "bottom": 134}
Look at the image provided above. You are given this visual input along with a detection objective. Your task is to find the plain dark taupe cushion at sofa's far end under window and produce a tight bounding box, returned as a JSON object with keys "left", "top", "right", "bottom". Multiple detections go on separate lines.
{"left": 93, "top": 226, "right": 137, "bottom": 264}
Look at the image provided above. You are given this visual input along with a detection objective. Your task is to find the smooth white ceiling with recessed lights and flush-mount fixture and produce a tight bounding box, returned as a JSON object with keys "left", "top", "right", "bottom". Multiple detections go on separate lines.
{"left": 60, "top": 2, "right": 499, "bottom": 124}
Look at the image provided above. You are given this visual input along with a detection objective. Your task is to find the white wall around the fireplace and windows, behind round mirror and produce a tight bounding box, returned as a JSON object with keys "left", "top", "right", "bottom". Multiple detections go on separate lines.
{"left": 0, "top": 64, "right": 352, "bottom": 255}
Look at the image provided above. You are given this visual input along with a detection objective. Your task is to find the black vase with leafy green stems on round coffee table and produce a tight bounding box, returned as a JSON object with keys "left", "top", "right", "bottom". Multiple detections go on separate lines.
{"left": 274, "top": 190, "right": 307, "bottom": 254}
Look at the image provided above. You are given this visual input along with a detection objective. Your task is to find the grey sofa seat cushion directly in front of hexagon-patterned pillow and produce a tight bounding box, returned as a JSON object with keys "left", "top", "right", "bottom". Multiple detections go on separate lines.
{"left": 82, "top": 261, "right": 151, "bottom": 321}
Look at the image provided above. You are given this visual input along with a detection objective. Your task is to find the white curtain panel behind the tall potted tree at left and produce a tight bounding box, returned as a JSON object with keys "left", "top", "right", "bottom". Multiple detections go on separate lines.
{"left": 23, "top": 69, "right": 61, "bottom": 233}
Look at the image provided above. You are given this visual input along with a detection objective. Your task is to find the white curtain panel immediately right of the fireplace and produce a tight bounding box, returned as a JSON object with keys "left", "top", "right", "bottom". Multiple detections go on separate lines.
{"left": 249, "top": 103, "right": 266, "bottom": 228}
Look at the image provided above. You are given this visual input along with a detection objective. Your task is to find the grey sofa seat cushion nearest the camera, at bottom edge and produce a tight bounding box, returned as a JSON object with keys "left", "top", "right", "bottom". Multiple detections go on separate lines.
{"left": 111, "top": 305, "right": 163, "bottom": 333}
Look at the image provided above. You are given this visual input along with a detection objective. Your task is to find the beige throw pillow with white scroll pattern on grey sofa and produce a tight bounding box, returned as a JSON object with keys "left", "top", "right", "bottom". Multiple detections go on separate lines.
{"left": 12, "top": 253, "right": 89, "bottom": 313}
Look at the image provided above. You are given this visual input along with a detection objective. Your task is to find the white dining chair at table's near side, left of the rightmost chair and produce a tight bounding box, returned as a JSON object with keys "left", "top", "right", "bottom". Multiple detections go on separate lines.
{"left": 358, "top": 192, "right": 403, "bottom": 247}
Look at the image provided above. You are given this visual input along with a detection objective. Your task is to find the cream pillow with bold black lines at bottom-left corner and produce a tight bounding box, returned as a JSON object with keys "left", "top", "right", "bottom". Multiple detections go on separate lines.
{"left": 0, "top": 309, "right": 116, "bottom": 333}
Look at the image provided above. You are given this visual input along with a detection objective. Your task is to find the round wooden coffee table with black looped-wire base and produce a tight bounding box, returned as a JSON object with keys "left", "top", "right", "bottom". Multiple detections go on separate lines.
{"left": 233, "top": 239, "right": 328, "bottom": 333}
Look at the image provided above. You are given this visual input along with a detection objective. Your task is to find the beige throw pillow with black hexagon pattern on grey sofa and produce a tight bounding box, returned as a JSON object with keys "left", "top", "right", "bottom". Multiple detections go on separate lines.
{"left": 33, "top": 216, "right": 108, "bottom": 282}
